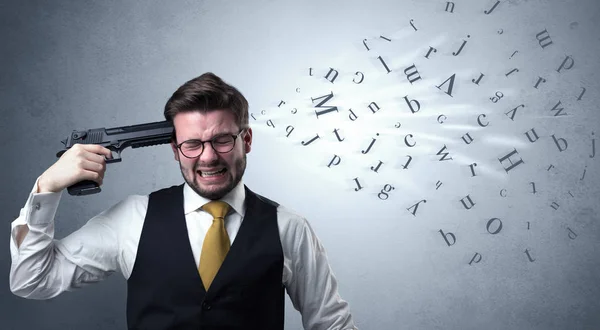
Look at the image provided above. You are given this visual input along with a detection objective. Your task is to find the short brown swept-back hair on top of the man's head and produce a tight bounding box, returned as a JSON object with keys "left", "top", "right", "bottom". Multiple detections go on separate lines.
{"left": 164, "top": 72, "right": 248, "bottom": 140}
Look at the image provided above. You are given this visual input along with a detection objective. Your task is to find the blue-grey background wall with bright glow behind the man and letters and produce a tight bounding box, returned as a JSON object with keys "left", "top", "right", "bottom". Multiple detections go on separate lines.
{"left": 0, "top": 0, "right": 600, "bottom": 329}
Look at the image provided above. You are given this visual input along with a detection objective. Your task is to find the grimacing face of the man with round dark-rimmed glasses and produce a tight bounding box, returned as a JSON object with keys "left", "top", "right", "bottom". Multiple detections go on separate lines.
{"left": 171, "top": 110, "right": 252, "bottom": 200}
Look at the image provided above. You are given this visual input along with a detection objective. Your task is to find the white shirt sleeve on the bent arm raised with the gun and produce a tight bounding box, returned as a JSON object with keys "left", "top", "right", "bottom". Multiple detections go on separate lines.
{"left": 9, "top": 178, "right": 118, "bottom": 299}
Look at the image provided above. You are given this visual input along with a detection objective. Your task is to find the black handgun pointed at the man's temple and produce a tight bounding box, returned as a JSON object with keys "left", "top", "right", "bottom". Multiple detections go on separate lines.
{"left": 56, "top": 121, "right": 173, "bottom": 196}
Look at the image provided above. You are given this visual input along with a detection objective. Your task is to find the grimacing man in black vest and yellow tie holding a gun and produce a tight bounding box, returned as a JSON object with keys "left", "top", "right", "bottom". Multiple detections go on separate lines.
{"left": 10, "top": 73, "right": 357, "bottom": 330}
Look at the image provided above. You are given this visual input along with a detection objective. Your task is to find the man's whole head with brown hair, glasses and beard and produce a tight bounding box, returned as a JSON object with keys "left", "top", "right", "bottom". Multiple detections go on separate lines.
{"left": 164, "top": 73, "right": 252, "bottom": 199}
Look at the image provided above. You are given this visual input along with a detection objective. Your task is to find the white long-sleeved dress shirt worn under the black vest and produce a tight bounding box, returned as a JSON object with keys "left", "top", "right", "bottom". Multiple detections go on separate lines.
{"left": 10, "top": 178, "right": 357, "bottom": 330}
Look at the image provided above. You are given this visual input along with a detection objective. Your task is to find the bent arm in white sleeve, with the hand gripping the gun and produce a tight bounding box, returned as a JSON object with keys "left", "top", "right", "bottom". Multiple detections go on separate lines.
{"left": 9, "top": 146, "right": 117, "bottom": 299}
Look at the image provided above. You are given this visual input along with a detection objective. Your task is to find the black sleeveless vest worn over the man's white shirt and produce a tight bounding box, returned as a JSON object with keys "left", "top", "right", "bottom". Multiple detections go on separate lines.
{"left": 127, "top": 185, "right": 285, "bottom": 330}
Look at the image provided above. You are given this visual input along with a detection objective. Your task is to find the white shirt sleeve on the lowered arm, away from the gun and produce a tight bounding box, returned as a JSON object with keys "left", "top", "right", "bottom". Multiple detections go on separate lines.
{"left": 286, "top": 218, "right": 358, "bottom": 330}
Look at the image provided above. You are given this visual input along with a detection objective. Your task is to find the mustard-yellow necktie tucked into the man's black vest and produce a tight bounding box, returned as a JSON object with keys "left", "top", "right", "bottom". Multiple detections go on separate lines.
{"left": 198, "top": 201, "right": 230, "bottom": 290}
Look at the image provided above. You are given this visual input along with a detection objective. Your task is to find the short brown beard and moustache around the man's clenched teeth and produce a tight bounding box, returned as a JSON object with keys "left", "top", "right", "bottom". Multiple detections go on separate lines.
{"left": 179, "top": 153, "right": 246, "bottom": 200}
